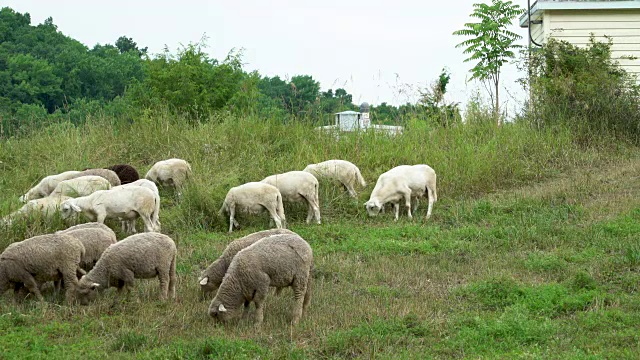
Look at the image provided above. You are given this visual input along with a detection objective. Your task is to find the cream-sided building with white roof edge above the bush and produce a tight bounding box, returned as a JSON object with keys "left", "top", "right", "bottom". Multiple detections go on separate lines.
{"left": 520, "top": 0, "right": 640, "bottom": 78}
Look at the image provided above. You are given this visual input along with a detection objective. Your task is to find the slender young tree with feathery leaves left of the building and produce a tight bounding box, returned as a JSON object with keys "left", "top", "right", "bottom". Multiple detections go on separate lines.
{"left": 453, "top": 0, "right": 522, "bottom": 126}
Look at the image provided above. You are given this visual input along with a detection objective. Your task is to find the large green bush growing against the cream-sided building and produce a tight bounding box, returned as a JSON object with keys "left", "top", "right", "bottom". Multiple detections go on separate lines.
{"left": 529, "top": 37, "right": 640, "bottom": 144}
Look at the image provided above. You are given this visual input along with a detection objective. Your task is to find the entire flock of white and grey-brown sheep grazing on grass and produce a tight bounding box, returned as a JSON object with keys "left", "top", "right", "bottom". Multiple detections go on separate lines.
{"left": 0, "top": 159, "right": 437, "bottom": 324}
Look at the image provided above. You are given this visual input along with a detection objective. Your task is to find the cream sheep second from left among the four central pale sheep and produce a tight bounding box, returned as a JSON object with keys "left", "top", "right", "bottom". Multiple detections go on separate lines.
{"left": 261, "top": 171, "right": 321, "bottom": 224}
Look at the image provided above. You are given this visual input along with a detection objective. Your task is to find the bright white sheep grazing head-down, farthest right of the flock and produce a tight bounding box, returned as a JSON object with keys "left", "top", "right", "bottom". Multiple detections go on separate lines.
{"left": 364, "top": 164, "right": 438, "bottom": 221}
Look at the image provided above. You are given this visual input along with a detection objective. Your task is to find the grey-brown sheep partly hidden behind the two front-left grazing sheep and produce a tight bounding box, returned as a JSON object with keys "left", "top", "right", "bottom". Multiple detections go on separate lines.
{"left": 57, "top": 222, "right": 118, "bottom": 271}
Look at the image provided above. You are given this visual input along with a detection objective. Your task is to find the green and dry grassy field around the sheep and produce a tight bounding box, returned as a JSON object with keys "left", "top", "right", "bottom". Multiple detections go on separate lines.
{"left": 0, "top": 115, "right": 640, "bottom": 359}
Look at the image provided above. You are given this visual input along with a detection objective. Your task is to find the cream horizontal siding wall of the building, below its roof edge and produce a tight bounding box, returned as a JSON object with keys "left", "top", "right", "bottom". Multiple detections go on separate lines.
{"left": 532, "top": 9, "right": 640, "bottom": 78}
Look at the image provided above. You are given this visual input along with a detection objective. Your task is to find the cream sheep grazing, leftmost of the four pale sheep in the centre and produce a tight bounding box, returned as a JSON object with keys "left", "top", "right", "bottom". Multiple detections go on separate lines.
{"left": 218, "top": 182, "right": 286, "bottom": 232}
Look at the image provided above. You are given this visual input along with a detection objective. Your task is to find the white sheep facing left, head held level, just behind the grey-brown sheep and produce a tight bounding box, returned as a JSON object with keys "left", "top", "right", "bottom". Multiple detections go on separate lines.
{"left": 60, "top": 186, "right": 160, "bottom": 233}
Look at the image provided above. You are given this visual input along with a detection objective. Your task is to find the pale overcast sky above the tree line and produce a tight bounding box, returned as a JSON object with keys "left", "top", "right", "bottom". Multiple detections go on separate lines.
{"left": 5, "top": 0, "right": 526, "bottom": 112}
